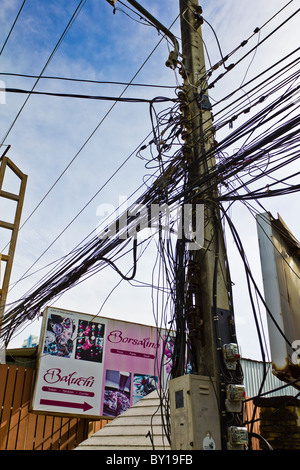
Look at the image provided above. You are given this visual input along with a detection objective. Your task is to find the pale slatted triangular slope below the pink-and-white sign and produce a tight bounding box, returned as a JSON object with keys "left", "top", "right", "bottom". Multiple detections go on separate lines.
{"left": 75, "top": 390, "right": 170, "bottom": 450}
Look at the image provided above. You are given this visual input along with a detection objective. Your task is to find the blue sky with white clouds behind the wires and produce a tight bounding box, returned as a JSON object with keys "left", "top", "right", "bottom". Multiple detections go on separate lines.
{"left": 0, "top": 0, "right": 300, "bottom": 360}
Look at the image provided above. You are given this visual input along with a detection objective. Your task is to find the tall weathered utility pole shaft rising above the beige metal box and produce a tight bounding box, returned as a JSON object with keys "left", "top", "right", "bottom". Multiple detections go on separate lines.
{"left": 180, "top": 0, "right": 221, "bottom": 377}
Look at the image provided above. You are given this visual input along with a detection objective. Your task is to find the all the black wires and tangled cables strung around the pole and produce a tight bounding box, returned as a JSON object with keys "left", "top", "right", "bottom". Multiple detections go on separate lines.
{"left": 0, "top": 1, "right": 300, "bottom": 448}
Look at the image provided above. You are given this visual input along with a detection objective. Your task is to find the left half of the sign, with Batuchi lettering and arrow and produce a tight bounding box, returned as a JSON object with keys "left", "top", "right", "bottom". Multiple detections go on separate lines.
{"left": 32, "top": 308, "right": 106, "bottom": 417}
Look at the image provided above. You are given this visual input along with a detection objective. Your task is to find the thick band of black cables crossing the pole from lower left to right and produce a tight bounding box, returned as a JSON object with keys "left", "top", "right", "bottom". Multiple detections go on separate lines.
{"left": 1, "top": 69, "right": 300, "bottom": 344}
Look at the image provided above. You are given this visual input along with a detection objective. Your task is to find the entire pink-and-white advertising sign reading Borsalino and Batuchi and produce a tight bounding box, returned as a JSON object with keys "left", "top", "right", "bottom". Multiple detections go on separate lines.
{"left": 32, "top": 307, "right": 172, "bottom": 419}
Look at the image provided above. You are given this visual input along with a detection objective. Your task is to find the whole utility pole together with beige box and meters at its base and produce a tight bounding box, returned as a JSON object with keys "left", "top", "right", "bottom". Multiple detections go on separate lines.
{"left": 170, "top": 0, "right": 248, "bottom": 450}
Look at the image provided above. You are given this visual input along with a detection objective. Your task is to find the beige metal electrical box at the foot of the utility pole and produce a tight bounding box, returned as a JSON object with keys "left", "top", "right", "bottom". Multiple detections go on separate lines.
{"left": 169, "top": 374, "right": 222, "bottom": 450}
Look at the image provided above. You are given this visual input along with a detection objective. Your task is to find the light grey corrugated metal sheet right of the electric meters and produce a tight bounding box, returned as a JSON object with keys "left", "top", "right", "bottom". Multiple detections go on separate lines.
{"left": 241, "top": 359, "right": 299, "bottom": 398}
